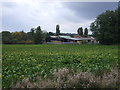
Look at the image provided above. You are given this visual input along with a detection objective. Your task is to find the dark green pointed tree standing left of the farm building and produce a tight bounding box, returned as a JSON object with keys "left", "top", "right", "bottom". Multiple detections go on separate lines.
{"left": 34, "top": 26, "right": 43, "bottom": 44}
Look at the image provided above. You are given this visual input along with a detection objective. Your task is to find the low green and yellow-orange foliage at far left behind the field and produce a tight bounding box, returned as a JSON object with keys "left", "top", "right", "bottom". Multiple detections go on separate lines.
{"left": 2, "top": 31, "right": 33, "bottom": 44}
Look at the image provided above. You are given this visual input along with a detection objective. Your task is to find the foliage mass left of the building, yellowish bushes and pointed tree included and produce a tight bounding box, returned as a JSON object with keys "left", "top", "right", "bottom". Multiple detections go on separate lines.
{"left": 2, "top": 26, "right": 48, "bottom": 44}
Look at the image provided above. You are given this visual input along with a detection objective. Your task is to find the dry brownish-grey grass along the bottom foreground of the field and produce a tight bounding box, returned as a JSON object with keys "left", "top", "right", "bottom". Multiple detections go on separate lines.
{"left": 13, "top": 68, "right": 119, "bottom": 89}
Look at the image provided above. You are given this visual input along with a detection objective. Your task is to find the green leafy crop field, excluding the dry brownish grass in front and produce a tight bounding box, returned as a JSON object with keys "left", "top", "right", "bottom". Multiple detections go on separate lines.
{"left": 2, "top": 44, "right": 118, "bottom": 88}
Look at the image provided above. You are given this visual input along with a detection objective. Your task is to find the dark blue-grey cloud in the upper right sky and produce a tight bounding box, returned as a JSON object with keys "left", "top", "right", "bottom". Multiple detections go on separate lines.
{"left": 63, "top": 2, "right": 118, "bottom": 19}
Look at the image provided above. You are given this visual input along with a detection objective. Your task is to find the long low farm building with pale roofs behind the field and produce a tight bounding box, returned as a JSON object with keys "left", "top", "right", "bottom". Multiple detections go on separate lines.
{"left": 48, "top": 35, "right": 96, "bottom": 44}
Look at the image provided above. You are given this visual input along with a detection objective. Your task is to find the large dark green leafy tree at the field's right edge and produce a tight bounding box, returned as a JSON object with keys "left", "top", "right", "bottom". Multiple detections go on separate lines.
{"left": 90, "top": 10, "right": 120, "bottom": 44}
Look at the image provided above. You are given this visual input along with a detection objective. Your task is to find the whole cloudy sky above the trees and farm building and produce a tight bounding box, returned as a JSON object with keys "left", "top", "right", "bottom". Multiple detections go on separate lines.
{"left": 0, "top": 0, "right": 118, "bottom": 33}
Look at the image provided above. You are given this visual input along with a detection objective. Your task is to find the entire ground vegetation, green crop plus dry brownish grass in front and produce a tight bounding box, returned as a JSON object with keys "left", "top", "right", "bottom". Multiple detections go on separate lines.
{"left": 2, "top": 44, "right": 119, "bottom": 88}
